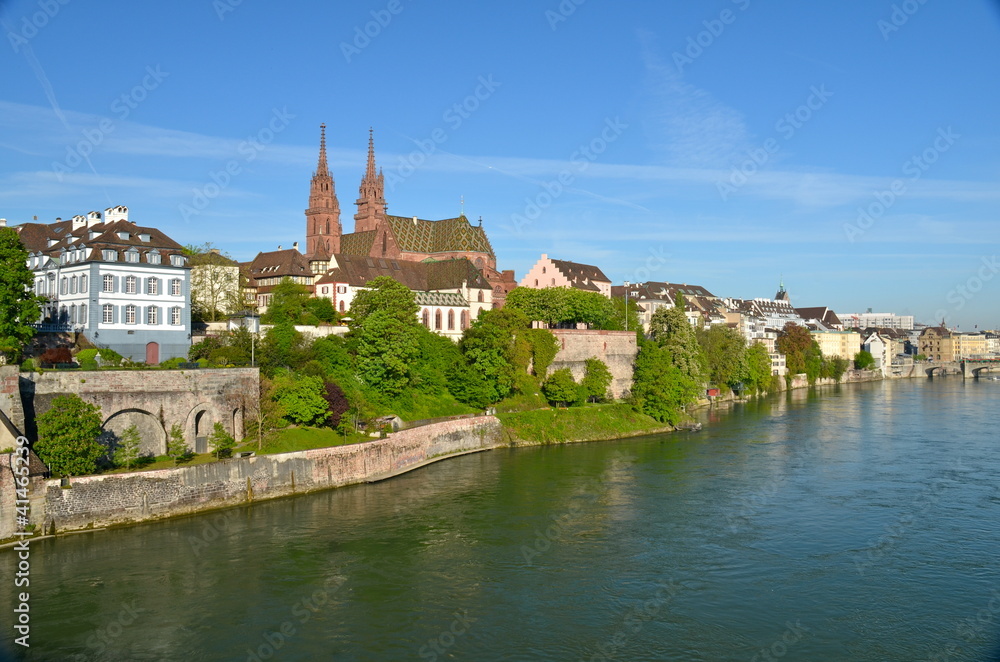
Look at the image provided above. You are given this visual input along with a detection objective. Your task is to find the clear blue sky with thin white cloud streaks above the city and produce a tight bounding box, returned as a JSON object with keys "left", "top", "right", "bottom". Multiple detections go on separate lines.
{"left": 0, "top": 0, "right": 1000, "bottom": 330}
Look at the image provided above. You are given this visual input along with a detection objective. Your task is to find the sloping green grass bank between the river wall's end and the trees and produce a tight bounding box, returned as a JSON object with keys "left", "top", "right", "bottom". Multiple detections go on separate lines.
{"left": 497, "top": 403, "right": 672, "bottom": 444}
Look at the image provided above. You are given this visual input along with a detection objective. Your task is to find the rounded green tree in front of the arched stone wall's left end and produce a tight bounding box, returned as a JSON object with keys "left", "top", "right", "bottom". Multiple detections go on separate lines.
{"left": 35, "top": 394, "right": 107, "bottom": 476}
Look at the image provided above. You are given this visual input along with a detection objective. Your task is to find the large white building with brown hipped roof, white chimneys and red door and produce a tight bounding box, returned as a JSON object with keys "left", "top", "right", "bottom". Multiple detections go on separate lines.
{"left": 14, "top": 206, "right": 191, "bottom": 364}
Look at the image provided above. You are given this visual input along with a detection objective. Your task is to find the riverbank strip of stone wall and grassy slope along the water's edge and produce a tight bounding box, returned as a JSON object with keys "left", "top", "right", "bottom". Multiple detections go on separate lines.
{"left": 0, "top": 370, "right": 908, "bottom": 541}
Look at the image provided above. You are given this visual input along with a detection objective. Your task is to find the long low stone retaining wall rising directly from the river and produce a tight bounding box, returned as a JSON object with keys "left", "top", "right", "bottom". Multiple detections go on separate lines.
{"left": 0, "top": 416, "right": 502, "bottom": 540}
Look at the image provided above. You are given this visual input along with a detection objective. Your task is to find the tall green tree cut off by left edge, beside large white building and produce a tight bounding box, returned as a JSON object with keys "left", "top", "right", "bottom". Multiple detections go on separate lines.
{"left": 0, "top": 227, "right": 42, "bottom": 363}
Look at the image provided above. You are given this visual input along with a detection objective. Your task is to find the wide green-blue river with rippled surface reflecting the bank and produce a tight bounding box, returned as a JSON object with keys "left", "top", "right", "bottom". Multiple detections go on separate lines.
{"left": 0, "top": 378, "right": 1000, "bottom": 662}
